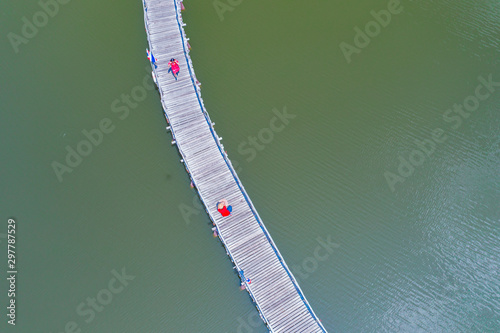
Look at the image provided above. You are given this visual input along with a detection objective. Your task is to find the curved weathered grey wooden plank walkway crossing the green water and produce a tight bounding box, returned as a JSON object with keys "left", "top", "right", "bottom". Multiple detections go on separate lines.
{"left": 143, "top": 0, "right": 326, "bottom": 333}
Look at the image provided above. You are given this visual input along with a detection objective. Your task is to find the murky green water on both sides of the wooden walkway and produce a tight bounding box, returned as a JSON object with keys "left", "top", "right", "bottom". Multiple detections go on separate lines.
{"left": 0, "top": 0, "right": 500, "bottom": 333}
